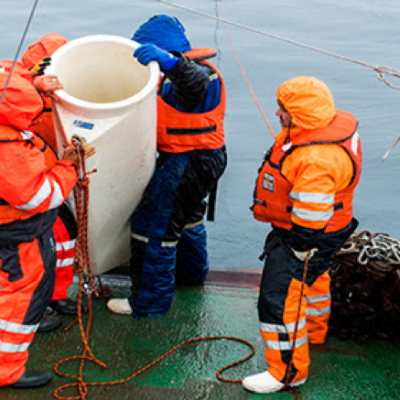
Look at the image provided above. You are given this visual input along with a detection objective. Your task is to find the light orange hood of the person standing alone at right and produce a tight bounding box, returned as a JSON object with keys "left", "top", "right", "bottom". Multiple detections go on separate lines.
{"left": 276, "top": 76, "right": 335, "bottom": 139}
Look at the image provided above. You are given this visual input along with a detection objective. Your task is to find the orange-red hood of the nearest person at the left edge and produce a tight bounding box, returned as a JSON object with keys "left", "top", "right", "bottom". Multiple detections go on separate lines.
{"left": 0, "top": 72, "right": 43, "bottom": 130}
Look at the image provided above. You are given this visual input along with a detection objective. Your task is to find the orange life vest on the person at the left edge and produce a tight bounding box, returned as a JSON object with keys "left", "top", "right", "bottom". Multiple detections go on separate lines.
{"left": 0, "top": 125, "right": 57, "bottom": 224}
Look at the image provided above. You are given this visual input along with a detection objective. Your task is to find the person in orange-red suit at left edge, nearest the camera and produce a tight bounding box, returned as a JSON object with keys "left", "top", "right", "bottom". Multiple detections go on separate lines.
{"left": 0, "top": 73, "right": 77, "bottom": 386}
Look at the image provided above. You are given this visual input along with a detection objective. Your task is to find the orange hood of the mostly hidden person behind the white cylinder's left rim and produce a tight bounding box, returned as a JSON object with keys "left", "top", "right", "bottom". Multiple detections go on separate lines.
{"left": 21, "top": 33, "right": 68, "bottom": 69}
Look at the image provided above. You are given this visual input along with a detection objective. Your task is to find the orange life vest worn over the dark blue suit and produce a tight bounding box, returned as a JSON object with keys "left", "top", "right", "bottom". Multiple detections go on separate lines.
{"left": 157, "top": 48, "right": 226, "bottom": 153}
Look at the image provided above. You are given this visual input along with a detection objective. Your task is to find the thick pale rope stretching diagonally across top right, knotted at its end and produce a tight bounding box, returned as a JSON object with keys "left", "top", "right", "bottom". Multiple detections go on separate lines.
{"left": 157, "top": 0, "right": 400, "bottom": 90}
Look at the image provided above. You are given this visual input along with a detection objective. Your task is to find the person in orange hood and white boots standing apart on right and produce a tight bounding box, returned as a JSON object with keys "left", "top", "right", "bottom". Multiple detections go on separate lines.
{"left": 243, "top": 76, "right": 362, "bottom": 393}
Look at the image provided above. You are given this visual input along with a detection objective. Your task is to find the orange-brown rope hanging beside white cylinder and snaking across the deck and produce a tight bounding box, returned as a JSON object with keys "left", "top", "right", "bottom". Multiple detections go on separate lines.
{"left": 54, "top": 137, "right": 255, "bottom": 400}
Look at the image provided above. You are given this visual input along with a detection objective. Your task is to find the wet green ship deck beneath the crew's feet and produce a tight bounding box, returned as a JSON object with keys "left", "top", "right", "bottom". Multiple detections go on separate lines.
{"left": 0, "top": 270, "right": 400, "bottom": 400}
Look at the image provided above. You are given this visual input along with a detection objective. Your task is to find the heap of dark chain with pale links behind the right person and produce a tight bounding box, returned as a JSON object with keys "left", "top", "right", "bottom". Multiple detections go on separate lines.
{"left": 329, "top": 231, "right": 400, "bottom": 342}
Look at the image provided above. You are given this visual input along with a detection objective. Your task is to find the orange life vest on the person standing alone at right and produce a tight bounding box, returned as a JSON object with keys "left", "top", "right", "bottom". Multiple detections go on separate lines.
{"left": 252, "top": 110, "right": 362, "bottom": 232}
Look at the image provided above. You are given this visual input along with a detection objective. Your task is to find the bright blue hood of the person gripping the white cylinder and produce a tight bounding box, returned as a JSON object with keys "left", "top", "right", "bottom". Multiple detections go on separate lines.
{"left": 132, "top": 15, "right": 192, "bottom": 53}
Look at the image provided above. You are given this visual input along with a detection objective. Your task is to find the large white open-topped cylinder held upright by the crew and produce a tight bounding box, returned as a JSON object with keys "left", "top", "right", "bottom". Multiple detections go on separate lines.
{"left": 46, "top": 35, "right": 159, "bottom": 274}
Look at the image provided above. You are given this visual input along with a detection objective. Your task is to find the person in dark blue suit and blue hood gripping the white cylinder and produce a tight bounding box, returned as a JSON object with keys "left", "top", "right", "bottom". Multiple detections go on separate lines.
{"left": 107, "top": 15, "right": 227, "bottom": 318}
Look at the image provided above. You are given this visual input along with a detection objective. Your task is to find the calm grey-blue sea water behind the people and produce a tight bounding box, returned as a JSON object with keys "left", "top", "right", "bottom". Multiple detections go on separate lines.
{"left": 0, "top": 0, "right": 400, "bottom": 269}
